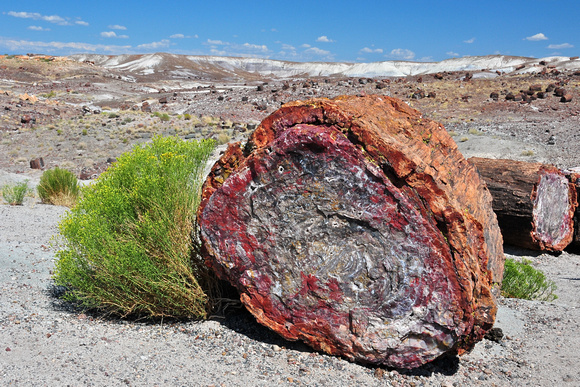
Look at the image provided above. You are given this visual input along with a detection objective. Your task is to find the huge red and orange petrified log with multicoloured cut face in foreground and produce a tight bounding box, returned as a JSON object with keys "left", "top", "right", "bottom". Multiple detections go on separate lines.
{"left": 198, "top": 96, "right": 504, "bottom": 368}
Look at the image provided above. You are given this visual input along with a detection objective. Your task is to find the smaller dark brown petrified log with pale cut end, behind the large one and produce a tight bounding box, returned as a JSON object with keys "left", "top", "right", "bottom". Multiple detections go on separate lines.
{"left": 469, "top": 157, "right": 578, "bottom": 251}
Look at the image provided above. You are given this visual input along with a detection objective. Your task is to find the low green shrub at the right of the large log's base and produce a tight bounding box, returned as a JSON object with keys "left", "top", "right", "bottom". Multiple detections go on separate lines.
{"left": 501, "top": 258, "right": 558, "bottom": 301}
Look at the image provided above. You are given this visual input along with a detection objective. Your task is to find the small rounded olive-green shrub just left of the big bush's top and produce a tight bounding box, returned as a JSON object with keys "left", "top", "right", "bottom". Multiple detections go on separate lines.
{"left": 36, "top": 167, "right": 79, "bottom": 207}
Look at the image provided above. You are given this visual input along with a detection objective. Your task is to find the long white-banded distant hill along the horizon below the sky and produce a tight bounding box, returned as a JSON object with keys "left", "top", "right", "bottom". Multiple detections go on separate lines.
{"left": 69, "top": 53, "right": 580, "bottom": 82}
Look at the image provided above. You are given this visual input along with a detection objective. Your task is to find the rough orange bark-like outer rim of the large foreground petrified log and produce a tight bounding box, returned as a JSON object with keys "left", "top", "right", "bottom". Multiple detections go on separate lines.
{"left": 198, "top": 96, "right": 504, "bottom": 360}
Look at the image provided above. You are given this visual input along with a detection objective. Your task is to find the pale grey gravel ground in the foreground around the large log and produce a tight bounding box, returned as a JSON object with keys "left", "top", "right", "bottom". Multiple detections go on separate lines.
{"left": 0, "top": 194, "right": 580, "bottom": 386}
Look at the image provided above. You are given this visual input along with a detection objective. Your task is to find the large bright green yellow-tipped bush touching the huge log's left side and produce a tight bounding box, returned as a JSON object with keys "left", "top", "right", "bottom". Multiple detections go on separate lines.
{"left": 54, "top": 136, "right": 215, "bottom": 318}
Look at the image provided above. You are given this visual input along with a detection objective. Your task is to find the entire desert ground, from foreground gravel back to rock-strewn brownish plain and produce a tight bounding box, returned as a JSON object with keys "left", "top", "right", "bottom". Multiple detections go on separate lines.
{"left": 0, "top": 59, "right": 580, "bottom": 386}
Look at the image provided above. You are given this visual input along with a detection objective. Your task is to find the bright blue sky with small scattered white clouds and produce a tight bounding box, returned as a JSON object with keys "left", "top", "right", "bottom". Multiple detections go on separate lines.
{"left": 0, "top": 0, "right": 580, "bottom": 62}
